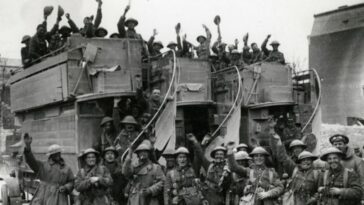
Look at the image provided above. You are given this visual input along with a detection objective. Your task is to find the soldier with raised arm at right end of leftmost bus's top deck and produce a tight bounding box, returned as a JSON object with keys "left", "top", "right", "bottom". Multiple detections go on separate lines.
{"left": 118, "top": 6, "right": 143, "bottom": 39}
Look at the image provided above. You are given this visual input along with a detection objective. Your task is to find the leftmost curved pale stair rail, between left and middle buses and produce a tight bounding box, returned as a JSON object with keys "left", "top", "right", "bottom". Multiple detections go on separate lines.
{"left": 118, "top": 50, "right": 179, "bottom": 160}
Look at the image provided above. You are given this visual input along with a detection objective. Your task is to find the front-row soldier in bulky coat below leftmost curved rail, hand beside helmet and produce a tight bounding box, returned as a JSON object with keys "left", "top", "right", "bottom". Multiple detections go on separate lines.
{"left": 123, "top": 143, "right": 165, "bottom": 205}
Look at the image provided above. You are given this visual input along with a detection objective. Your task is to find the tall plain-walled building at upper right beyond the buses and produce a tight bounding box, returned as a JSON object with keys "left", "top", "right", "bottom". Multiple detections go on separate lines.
{"left": 309, "top": 4, "right": 364, "bottom": 125}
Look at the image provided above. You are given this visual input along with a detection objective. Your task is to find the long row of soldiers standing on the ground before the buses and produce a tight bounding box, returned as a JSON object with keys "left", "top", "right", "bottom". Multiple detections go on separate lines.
{"left": 17, "top": 113, "right": 364, "bottom": 205}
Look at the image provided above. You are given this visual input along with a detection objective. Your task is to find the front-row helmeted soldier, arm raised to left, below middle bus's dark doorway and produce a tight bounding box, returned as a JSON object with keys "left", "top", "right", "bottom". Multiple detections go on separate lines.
{"left": 187, "top": 134, "right": 231, "bottom": 205}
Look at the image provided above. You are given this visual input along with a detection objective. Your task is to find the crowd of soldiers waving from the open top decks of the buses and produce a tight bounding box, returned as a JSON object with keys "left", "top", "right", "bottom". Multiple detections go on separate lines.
{"left": 21, "top": 0, "right": 285, "bottom": 70}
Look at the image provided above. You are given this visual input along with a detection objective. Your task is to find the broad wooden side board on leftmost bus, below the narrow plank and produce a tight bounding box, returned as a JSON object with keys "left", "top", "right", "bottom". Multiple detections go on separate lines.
{"left": 11, "top": 65, "right": 64, "bottom": 112}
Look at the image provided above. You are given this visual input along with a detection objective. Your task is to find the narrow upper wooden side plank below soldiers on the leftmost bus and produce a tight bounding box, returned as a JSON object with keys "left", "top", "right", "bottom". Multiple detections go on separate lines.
{"left": 9, "top": 52, "right": 68, "bottom": 84}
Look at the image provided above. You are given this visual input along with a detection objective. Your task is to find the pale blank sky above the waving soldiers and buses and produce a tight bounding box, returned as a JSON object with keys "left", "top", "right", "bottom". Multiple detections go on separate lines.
{"left": 0, "top": 0, "right": 363, "bottom": 69}
